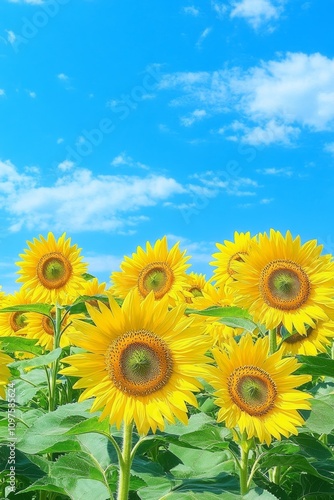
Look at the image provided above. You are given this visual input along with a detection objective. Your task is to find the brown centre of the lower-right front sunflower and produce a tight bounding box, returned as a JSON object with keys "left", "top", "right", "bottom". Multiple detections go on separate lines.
{"left": 227, "top": 365, "right": 277, "bottom": 416}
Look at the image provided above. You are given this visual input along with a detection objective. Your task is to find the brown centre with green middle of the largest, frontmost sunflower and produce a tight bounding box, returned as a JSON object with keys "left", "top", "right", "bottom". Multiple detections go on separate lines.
{"left": 105, "top": 330, "right": 173, "bottom": 396}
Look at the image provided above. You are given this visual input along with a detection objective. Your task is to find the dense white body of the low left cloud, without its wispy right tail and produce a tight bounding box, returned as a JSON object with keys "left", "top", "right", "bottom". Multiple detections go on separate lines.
{"left": 0, "top": 161, "right": 186, "bottom": 232}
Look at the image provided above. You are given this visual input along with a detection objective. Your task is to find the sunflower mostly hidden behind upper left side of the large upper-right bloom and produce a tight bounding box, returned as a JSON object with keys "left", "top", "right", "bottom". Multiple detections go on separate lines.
{"left": 210, "top": 231, "right": 256, "bottom": 287}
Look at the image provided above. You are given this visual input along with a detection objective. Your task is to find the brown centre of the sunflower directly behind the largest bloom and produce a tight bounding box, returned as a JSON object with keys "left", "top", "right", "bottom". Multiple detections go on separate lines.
{"left": 138, "top": 262, "right": 174, "bottom": 299}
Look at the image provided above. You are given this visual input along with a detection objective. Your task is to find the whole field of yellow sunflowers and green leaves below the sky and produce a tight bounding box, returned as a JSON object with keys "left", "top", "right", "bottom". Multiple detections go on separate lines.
{"left": 0, "top": 230, "right": 334, "bottom": 500}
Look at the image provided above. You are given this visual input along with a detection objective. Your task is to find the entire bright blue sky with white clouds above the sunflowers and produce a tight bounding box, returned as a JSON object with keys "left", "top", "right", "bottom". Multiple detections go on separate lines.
{"left": 0, "top": 0, "right": 334, "bottom": 293}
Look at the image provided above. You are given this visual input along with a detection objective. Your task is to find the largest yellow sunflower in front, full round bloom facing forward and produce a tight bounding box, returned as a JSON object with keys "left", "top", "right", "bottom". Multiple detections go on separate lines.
{"left": 61, "top": 290, "right": 210, "bottom": 434}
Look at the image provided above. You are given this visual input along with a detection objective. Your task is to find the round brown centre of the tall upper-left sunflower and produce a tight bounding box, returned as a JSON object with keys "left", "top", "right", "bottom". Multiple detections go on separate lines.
{"left": 37, "top": 252, "right": 72, "bottom": 290}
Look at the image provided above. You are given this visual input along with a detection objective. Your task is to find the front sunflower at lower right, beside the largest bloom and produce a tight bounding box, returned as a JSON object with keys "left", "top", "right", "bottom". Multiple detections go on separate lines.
{"left": 209, "top": 334, "right": 311, "bottom": 445}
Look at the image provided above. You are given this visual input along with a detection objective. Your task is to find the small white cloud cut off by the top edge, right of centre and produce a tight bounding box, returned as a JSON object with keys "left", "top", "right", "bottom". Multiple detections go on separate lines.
{"left": 230, "top": 0, "right": 282, "bottom": 29}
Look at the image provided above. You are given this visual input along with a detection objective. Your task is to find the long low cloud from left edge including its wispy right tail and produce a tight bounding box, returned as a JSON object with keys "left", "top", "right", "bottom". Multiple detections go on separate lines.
{"left": 0, "top": 160, "right": 261, "bottom": 234}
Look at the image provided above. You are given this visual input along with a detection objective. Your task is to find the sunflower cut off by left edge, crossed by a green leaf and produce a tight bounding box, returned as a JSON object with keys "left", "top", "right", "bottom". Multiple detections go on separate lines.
{"left": 0, "top": 289, "right": 32, "bottom": 337}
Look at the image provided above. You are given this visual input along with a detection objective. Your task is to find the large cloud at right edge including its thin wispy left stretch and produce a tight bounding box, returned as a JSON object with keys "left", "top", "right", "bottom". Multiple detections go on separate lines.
{"left": 159, "top": 53, "right": 334, "bottom": 145}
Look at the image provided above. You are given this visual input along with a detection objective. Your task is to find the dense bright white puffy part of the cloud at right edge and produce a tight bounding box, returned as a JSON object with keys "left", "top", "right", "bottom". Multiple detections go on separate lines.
{"left": 232, "top": 53, "right": 334, "bottom": 130}
